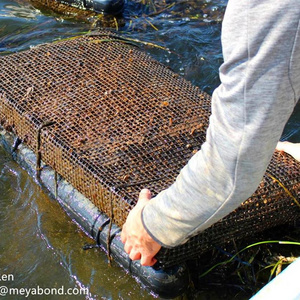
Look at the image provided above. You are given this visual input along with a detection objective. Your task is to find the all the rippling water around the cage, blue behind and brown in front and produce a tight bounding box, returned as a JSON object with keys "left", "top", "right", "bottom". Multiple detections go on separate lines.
{"left": 0, "top": 0, "right": 300, "bottom": 299}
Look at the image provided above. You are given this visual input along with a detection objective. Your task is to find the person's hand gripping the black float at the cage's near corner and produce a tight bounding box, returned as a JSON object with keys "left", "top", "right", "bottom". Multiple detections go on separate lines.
{"left": 121, "top": 189, "right": 161, "bottom": 266}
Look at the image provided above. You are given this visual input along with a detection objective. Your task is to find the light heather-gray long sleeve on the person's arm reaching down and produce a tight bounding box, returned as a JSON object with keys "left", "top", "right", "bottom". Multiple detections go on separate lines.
{"left": 142, "top": 0, "right": 300, "bottom": 247}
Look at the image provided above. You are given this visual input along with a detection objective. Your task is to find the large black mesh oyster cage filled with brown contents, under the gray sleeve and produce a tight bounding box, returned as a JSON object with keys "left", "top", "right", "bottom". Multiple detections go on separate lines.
{"left": 0, "top": 31, "right": 300, "bottom": 268}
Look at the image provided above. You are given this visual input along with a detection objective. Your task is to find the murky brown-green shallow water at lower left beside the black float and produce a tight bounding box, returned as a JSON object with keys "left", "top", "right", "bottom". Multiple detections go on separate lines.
{"left": 0, "top": 149, "right": 159, "bottom": 299}
